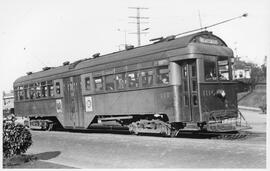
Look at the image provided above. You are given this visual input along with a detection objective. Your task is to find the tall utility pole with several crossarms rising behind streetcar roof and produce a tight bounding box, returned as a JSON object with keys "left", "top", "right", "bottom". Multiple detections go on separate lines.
{"left": 128, "top": 7, "right": 149, "bottom": 46}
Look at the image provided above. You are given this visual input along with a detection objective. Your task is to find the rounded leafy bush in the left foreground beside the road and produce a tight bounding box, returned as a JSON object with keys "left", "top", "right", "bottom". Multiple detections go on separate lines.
{"left": 3, "top": 116, "right": 32, "bottom": 158}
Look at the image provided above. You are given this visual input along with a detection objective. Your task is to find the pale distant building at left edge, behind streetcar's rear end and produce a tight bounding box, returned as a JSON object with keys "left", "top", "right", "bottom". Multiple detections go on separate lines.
{"left": 3, "top": 91, "right": 14, "bottom": 117}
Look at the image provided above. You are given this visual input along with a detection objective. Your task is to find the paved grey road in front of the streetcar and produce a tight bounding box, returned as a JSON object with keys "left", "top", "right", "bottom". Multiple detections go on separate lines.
{"left": 25, "top": 109, "right": 266, "bottom": 168}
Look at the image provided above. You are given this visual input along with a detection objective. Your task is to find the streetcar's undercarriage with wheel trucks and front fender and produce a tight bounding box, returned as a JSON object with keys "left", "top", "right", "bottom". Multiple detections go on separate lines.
{"left": 24, "top": 111, "right": 251, "bottom": 137}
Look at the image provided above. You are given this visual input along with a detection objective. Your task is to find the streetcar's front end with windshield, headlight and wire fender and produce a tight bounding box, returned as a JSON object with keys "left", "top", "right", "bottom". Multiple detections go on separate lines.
{"left": 199, "top": 55, "right": 250, "bottom": 132}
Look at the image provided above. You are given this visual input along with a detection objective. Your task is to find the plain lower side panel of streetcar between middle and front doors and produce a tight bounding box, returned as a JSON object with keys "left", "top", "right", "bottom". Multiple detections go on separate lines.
{"left": 85, "top": 86, "right": 174, "bottom": 121}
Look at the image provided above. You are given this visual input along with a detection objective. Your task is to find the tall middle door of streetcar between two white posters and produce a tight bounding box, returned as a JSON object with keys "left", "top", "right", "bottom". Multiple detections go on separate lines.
{"left": 63, "top": 76, "right": 83, "bottom": 128}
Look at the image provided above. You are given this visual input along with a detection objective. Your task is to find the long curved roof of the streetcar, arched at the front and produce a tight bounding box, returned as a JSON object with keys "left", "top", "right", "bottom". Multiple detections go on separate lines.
{"left": 14, "top": 31, "right": 227, "bottom": 85}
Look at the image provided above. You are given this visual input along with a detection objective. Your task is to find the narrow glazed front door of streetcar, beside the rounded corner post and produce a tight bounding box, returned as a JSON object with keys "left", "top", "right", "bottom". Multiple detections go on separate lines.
{"left": 180, "top": 59, "right": 200, "bottom": 122}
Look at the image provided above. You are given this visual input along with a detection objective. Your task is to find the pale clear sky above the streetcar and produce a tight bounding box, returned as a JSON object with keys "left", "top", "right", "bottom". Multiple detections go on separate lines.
{"left": 0, "top": 0, "right": 270, "bottom": 91}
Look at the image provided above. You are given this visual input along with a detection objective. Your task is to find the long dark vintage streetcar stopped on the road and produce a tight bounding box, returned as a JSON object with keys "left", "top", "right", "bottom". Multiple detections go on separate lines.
{"left": 14, "top": 31, "right": 248, "bottom": 136}
